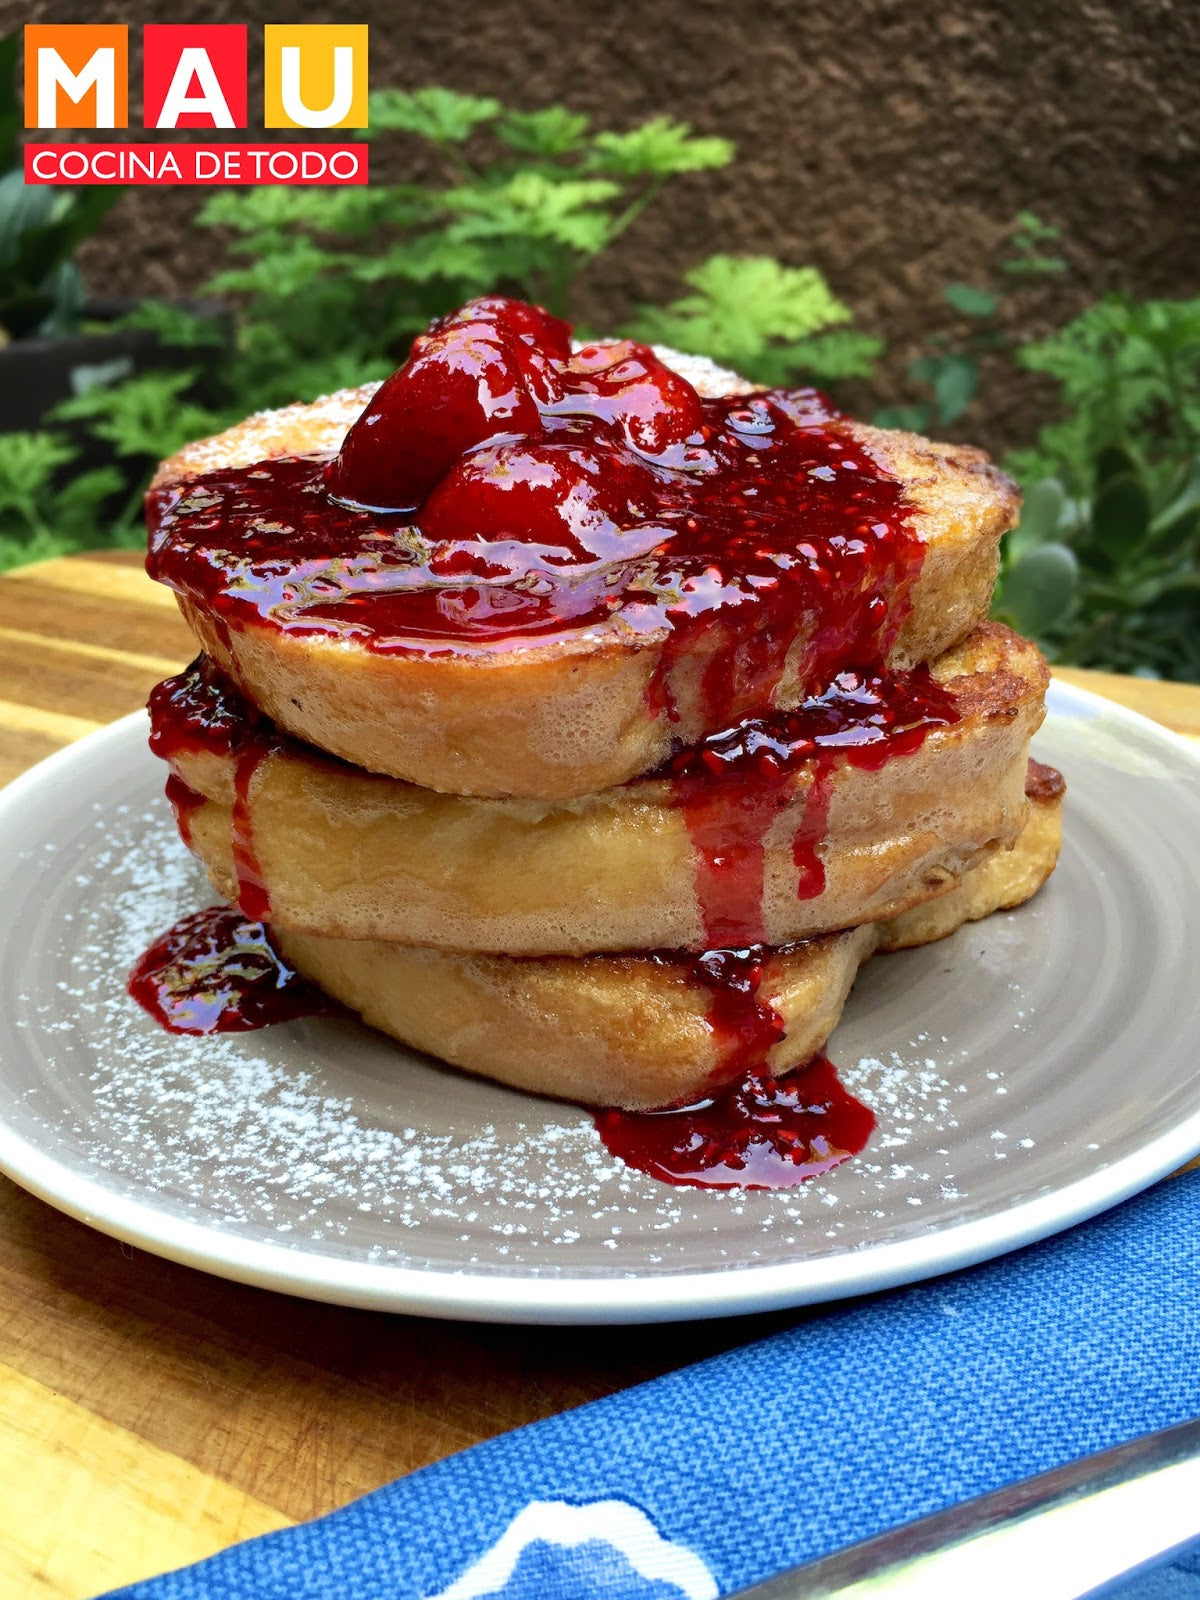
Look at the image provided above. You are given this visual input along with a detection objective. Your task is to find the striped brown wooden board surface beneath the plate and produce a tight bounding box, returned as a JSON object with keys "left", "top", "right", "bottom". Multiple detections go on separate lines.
{"left": 0, "top": 554, "right": 1200, "bottom": 1600}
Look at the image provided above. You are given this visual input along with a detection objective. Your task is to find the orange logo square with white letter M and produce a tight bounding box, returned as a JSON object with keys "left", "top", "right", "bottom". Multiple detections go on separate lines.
{"left": 26, "top": 24, "right": 130, "bottom": 128}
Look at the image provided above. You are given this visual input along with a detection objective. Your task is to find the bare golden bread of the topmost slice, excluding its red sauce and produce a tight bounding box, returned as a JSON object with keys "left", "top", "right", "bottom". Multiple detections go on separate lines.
{"left": 145, "top": 352, "right": 1019, "bottom": 800}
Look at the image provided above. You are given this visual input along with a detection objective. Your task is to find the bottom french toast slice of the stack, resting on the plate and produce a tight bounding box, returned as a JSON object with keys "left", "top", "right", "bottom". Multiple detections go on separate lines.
{"left": 275, "top": 770, "right": 1061, "bottom": 1109}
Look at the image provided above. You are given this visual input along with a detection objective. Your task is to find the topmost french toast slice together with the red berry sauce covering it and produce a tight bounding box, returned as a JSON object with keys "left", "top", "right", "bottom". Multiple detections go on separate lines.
{"left": 147, "top": 301, "right": 1019, "bottom": 800}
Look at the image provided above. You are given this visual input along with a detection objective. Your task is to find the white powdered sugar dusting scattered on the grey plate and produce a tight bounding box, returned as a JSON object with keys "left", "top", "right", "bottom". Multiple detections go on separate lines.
{"left": 4, "top": 755, "right": 1062, "bottom": 1277}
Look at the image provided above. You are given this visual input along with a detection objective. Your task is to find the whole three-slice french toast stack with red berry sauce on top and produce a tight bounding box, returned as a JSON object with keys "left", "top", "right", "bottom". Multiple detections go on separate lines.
{"left": 149, "top": 298, "right": 1061, "bottom": 1109}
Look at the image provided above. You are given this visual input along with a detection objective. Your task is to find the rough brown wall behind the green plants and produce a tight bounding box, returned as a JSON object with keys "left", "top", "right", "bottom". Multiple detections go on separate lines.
{"left": 11, "top": 0, "right": 1200, "bottom": 448}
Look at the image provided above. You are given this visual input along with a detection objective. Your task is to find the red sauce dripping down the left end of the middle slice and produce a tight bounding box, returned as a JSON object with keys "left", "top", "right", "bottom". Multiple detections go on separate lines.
{"left": 149, "top": 656, "right": 276, "bottom": 922}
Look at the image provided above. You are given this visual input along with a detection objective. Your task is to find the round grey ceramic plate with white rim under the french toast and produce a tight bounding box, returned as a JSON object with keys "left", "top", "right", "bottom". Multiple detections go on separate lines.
{"left": 0, "top": 685, "right": 1200, "bottom": 1322}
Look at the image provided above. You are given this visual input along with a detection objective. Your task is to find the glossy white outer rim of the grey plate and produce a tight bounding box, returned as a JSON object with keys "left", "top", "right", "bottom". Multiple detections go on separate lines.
{"left": 0, "top": 678, "right": 1200, "bottom": 1325}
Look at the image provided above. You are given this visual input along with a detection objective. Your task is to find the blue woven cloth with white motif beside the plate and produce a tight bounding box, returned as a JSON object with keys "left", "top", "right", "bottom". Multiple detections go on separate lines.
{"left": 101, "top": 1173, "right": 1200, "bottom": 1600}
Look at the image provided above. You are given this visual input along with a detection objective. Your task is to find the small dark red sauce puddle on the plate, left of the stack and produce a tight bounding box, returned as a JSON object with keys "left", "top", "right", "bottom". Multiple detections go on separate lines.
{"left": 128, "top": 906, "right": 330, "bottom": 1034}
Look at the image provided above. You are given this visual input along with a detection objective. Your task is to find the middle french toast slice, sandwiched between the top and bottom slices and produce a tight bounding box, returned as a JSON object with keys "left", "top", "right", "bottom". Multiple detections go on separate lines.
{"left": 164, "top": 622, "right": 1048, "bottom": 955}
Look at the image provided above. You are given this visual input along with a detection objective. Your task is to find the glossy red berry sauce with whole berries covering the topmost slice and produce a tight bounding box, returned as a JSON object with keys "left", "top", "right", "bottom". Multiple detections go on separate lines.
{"left": 147, "top": 296, "right": 923, "bottom": 728}
